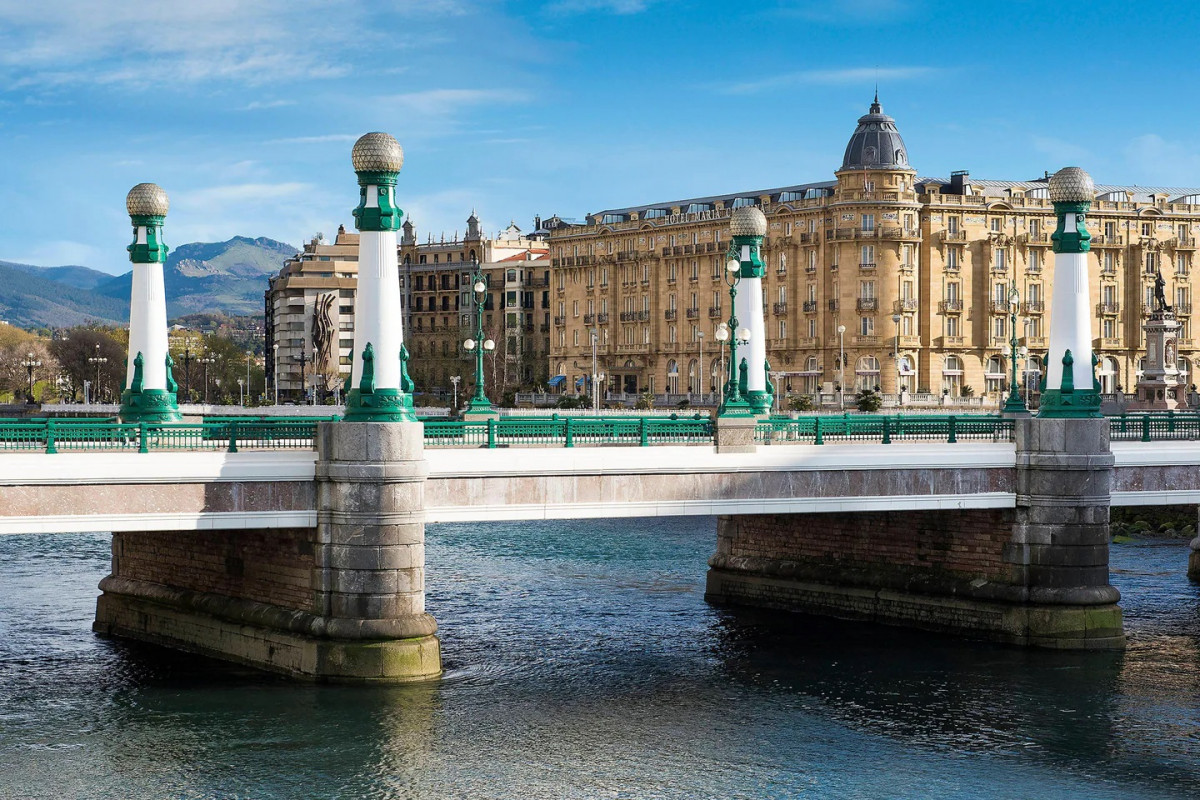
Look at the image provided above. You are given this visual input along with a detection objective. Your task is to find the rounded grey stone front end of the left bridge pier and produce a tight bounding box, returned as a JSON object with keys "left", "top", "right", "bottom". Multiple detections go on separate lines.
{"left": 313, "top": 422, "right": 442, "bottom": 681}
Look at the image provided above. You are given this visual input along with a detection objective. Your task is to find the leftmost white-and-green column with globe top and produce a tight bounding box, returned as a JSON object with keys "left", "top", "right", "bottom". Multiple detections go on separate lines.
{"left": 120, "top": 184, "right": 182, "bottom": 422}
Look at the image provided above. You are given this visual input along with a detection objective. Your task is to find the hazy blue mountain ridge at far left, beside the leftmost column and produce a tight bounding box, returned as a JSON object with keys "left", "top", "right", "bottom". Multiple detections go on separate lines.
{"left": 0, "top": 261, "right": 130, "bottom": 327}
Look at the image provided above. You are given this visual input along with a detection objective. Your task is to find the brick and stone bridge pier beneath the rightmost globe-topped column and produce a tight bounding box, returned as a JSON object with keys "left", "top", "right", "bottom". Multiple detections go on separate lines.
{"left": 707, "top": 419, "right": 1123, "bottom": 649}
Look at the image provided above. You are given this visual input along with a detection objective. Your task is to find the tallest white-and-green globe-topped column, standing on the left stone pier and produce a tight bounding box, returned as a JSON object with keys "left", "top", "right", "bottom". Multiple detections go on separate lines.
{"left": 344, "top": 132, "right": 416, "bottom": 422}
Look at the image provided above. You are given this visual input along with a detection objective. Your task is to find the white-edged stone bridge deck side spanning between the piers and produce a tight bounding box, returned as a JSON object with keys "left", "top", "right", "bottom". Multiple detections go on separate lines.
{"left": 0, "top": 441, "right": 1200, "bottom": 534}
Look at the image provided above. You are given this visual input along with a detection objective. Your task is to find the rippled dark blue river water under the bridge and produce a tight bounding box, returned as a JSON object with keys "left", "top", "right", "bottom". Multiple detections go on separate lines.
{"left": 0, "top": 518, "right": 1200, "bottom": 799}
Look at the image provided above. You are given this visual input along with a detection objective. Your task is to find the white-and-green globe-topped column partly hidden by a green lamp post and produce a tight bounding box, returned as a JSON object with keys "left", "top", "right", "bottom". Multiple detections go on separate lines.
{"left": 730, "top": 205, "right": 772, "bottom": 415}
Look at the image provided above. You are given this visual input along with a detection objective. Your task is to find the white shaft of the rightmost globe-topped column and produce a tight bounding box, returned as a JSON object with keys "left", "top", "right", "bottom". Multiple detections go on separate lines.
{"left": 1046, "top": 245, "right": 1092, "bottom": 391}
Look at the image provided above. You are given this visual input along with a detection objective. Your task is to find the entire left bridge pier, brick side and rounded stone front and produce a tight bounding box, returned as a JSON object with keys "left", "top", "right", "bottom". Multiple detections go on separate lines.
{"left": 94, "top": 422, "right": 442, "bottom": 682}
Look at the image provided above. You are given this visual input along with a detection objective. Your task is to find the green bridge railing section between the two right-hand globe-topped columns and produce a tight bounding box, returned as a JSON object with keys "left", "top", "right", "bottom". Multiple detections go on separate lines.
{"left": 755, "top": 414, "right": 1013, "bottom": 445}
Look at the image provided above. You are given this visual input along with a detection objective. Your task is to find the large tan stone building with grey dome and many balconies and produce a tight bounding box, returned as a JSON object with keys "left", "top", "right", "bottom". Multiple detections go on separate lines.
{"left": 550, "top": 102, "right": 1200, "bottom": 399}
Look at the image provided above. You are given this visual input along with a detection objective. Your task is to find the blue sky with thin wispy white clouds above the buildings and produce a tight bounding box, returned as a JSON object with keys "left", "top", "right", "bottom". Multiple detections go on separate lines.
{"left": 0, "top": 0, "right": 1200, "bottom": 273}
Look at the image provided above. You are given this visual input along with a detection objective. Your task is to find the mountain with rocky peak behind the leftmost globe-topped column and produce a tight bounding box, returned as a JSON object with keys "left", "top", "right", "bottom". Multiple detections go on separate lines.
{"left": 96, "top": 236, "right": 296, "bottom": 317}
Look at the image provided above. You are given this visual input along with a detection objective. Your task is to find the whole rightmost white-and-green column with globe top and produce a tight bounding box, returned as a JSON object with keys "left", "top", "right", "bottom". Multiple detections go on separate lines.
{"left": 1038, "top": 167, "right": 1100, "bottom": 417}
